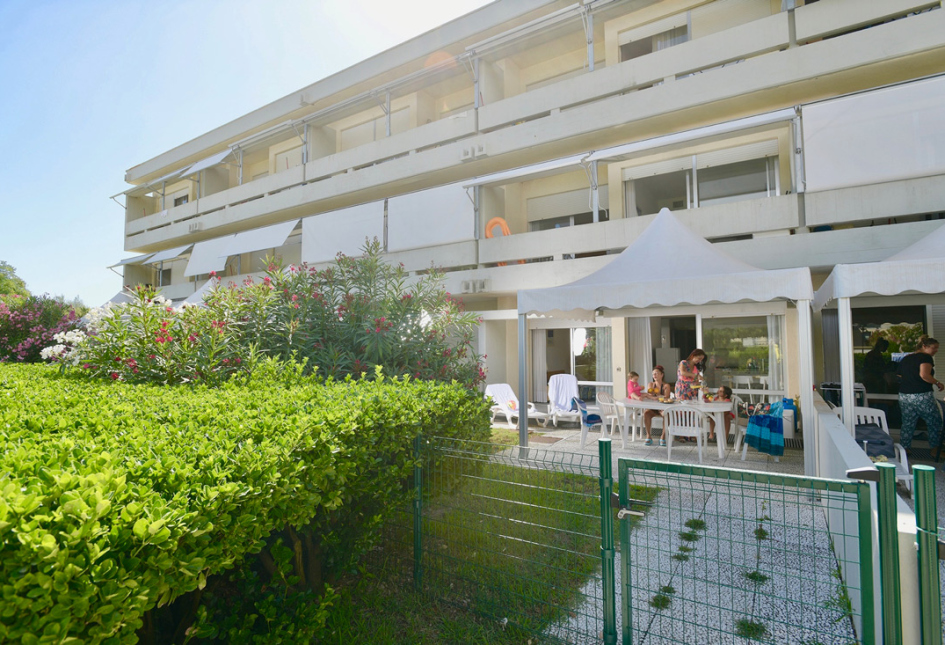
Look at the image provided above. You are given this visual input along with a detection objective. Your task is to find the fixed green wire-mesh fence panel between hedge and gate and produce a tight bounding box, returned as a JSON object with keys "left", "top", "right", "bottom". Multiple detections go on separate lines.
{"left": 417, "top": 438, "right": 620, "bottom": 643}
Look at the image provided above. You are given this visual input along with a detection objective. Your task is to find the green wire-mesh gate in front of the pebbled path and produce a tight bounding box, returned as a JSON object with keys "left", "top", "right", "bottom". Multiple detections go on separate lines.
{"left": 616, "top": 459, "right": 875, "bottom": 645}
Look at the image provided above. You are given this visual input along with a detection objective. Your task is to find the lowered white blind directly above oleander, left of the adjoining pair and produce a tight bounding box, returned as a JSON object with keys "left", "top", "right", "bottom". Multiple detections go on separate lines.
{"left": 302, "top": 200, "right": 384, "bottom": 264}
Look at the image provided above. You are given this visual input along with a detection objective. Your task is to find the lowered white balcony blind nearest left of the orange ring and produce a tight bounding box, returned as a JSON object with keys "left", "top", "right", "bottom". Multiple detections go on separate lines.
{"left": 387, "top": 184, "right": 475, "bottom": 251}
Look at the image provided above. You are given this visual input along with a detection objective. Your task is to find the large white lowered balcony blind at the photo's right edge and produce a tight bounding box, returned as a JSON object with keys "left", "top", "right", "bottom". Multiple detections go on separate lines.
{"left": 803, "top": 77, "right": 945, "bottom": 192}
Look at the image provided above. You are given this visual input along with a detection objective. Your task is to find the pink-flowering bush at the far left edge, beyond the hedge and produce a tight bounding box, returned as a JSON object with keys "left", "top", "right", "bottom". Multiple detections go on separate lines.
{"left": 0, "top": 294, "right": 79, "bottom": 363}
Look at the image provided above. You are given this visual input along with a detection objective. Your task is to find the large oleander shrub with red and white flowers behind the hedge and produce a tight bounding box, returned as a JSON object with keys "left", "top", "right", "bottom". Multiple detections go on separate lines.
{"left": 49, "top": 240, "right": 485, "bottom": 387}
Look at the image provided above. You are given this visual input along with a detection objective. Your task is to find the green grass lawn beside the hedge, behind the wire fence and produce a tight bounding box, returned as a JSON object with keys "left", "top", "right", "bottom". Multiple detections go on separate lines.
{"left": 320, "top": 436, "right": 656, "bottom": 644}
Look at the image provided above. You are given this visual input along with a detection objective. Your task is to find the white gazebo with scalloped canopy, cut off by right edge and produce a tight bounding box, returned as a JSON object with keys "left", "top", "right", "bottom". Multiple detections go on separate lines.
{"left": 814, "top": 220, "right": 945, "bottom": 434}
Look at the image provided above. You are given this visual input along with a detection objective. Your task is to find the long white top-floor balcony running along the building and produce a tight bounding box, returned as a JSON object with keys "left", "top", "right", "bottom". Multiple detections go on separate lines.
{"left": 125, "top": 0, "right": 945, "bottom": 250}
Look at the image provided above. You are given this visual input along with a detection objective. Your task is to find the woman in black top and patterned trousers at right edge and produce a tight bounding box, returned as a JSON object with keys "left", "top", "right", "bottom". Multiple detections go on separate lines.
{"left": 899, "top": 336, "right": 945, "bottom": 449}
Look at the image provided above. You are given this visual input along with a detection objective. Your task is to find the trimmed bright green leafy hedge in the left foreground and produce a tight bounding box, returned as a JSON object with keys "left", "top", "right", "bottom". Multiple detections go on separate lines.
{"left": 0, "top": 366, "right": 488, "bottom": 643}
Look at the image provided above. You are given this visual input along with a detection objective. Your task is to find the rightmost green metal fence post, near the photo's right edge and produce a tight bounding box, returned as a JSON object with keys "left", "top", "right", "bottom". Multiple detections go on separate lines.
{"left": 912, "top": 466, "right": 942, "bottom": 645}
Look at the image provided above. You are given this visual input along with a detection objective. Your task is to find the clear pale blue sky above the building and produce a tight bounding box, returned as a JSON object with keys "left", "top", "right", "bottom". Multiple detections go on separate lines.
{"left": 0, "top": 0, "right": 488, "bottom": 306}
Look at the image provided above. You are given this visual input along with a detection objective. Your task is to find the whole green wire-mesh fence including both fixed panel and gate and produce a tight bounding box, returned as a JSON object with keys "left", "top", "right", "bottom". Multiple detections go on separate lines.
{"left": 399, "top": 438, "right": 880, "bottom": 645}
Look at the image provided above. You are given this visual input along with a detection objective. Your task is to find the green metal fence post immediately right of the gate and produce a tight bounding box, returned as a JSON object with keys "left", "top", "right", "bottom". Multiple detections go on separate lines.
{"left": 876, "top": 464, "right": 902, "bottom": 643}
